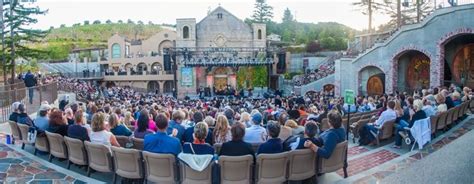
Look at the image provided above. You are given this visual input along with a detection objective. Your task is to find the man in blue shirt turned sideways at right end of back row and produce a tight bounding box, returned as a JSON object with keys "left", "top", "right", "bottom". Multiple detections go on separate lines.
{"left": 304, "top": 111, "right": 346, "bottom": 159}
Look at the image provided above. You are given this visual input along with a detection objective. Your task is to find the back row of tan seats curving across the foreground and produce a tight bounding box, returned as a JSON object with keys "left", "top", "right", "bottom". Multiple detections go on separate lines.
{"left": 6, "top": 122, "right": 348, "bottom": 183}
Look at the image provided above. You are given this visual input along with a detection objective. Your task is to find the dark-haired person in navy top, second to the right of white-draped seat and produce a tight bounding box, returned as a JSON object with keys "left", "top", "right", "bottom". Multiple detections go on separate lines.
{"left": 257, "top": 122, "right": 283, "bottom": 154}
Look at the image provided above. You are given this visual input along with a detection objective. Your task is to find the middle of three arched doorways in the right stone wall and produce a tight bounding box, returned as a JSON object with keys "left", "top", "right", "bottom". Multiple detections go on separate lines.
{"left": 396, "top": 50, "right": 431, "bottom": 93}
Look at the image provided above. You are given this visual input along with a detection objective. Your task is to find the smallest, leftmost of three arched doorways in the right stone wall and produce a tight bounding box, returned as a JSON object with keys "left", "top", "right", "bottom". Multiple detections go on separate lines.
{"left": 359, "top": 66, "right": 385, "bottom": 96}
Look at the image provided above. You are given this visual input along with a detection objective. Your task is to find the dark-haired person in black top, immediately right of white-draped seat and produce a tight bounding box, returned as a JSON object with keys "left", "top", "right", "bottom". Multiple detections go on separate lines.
{"left": 219, "top": 123, "right": 255, "bottom": 157}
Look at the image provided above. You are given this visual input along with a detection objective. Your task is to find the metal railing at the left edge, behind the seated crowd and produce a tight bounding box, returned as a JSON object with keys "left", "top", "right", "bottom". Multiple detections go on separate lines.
{"left": 0, "top": 82, "right": 58, "bottom": 122}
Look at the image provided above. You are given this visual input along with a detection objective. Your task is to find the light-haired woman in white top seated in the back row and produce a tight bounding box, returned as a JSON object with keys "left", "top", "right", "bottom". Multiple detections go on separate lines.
{"left": 90, "top": 112, "right": 120, "bottom": 147}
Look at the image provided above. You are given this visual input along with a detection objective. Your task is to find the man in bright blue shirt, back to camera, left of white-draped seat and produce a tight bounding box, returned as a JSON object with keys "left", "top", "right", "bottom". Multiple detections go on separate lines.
{"left": 143, "top": 114, "right": 181, "bottom": 156}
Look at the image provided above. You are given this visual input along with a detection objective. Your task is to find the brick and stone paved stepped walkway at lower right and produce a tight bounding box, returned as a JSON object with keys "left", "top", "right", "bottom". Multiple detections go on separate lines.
{"left": 326, "top": 115, "right": 474, "bottom": 184}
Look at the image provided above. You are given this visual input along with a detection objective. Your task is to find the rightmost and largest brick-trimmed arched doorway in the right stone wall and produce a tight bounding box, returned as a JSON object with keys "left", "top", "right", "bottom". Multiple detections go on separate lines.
{"left": 444, "top": 34, "right": 474, "bottom": 88}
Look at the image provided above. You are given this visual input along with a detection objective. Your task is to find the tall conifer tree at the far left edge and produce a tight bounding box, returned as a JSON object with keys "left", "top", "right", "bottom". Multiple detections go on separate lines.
{"left": 2, "top": 0, "right": 48, "bottom": 83}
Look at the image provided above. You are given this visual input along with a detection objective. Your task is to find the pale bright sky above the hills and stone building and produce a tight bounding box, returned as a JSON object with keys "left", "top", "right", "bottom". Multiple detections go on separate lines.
{"left": 29, "top": 0, "right": 392, "bottom": 30}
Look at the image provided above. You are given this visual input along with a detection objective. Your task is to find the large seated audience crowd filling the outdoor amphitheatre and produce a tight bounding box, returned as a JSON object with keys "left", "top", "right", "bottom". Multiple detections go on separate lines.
{"left": 10, "top": 76, "right": 472, "bottom": 181}
